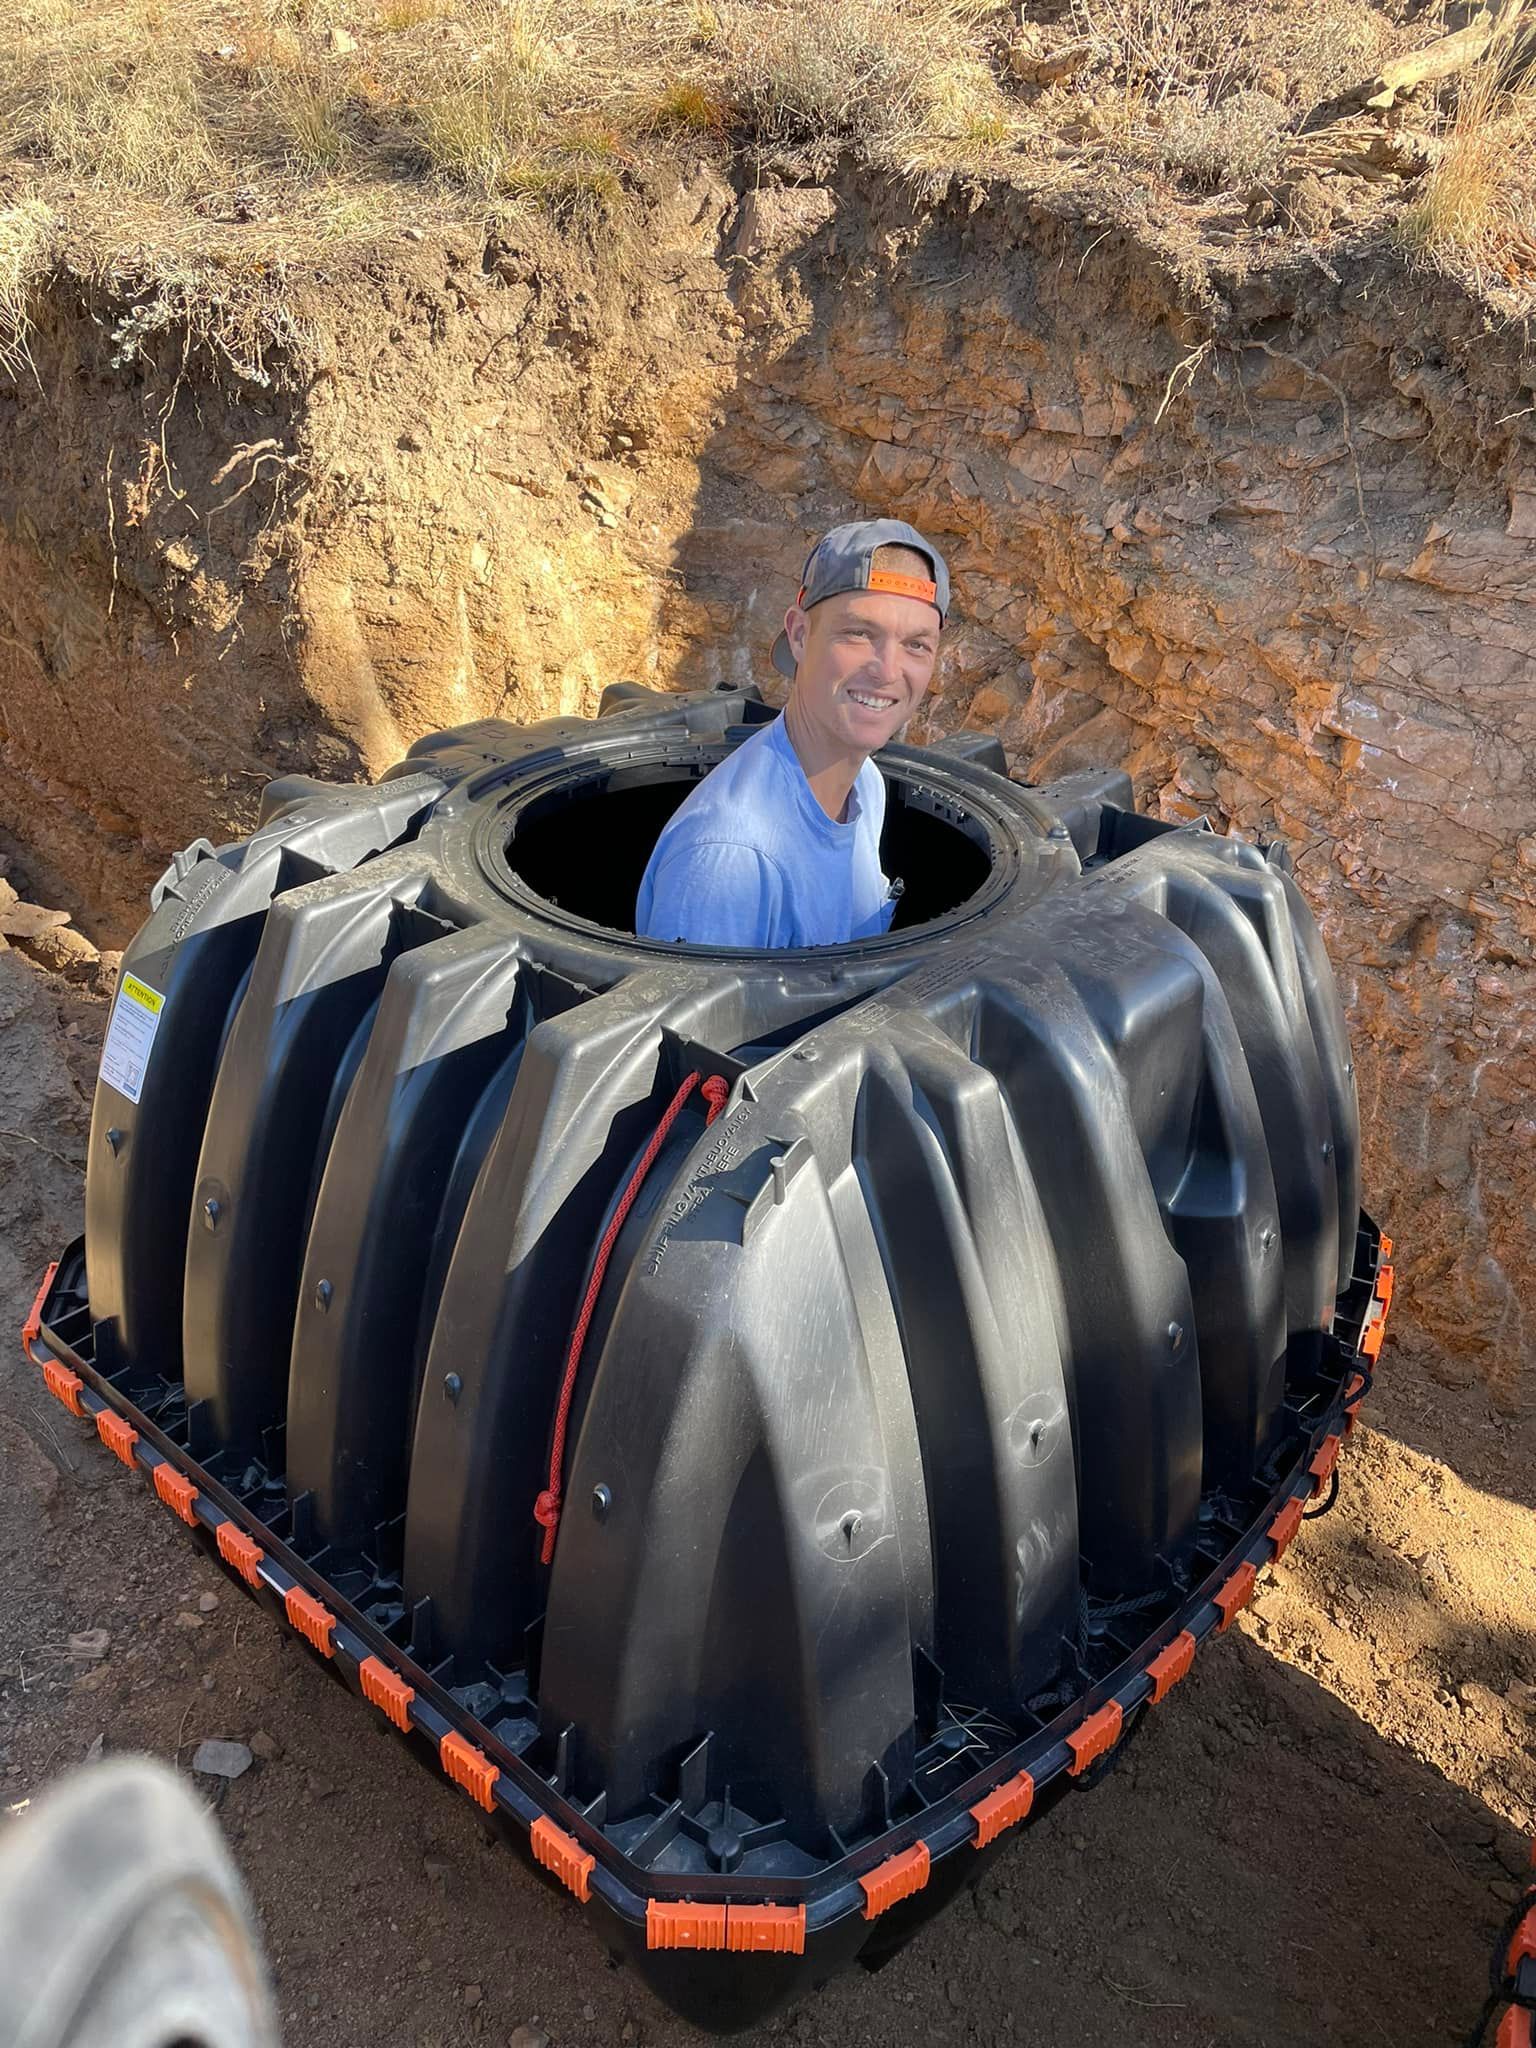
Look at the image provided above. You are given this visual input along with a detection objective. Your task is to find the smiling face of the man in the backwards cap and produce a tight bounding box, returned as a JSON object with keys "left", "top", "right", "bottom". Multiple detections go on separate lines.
{"left": 784, "top": 590, "right": 938, "bottom": 754}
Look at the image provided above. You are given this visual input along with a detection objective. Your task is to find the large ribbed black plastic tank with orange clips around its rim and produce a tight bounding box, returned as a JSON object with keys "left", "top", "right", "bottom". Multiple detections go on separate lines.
{"left": 27, "top": 686, "right": 1384, "bottom": 2028}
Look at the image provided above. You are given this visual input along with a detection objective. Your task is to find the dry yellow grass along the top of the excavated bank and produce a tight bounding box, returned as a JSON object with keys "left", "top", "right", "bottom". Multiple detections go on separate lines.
{"left": 0, "top": 0, "right": 1532, "bottom": 373}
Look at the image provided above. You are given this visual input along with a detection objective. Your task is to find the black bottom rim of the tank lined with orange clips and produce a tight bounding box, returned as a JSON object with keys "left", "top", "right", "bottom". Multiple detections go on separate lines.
{"left": 23, "top": 1214, "right": 1393, "bottom": 2032}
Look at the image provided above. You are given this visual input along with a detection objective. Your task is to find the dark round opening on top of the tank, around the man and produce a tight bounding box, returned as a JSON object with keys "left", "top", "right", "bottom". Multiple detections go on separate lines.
{"left": 504, "top": 748, "right": 993, "bottom": 934}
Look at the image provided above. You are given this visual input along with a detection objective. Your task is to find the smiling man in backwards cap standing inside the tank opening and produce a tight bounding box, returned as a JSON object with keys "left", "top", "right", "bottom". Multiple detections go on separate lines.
{"left": 635, "top": 518, "right": 950, "bottom": 946}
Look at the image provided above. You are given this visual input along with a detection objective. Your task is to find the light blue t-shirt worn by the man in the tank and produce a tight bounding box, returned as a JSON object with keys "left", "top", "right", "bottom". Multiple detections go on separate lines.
{"left": 635, "top": 717, "right": 895, "bottom": 946}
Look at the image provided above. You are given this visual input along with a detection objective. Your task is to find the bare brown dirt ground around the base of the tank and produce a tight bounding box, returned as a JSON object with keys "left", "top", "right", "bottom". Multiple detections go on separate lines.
{"left": 0, "top": 954, "right": 1536, "bottom": 2048}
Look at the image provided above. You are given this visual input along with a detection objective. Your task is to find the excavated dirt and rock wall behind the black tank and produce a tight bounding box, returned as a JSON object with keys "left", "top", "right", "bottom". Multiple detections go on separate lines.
{"left": 0, "top": 168, "right": 1536, "bottom": 1409}
